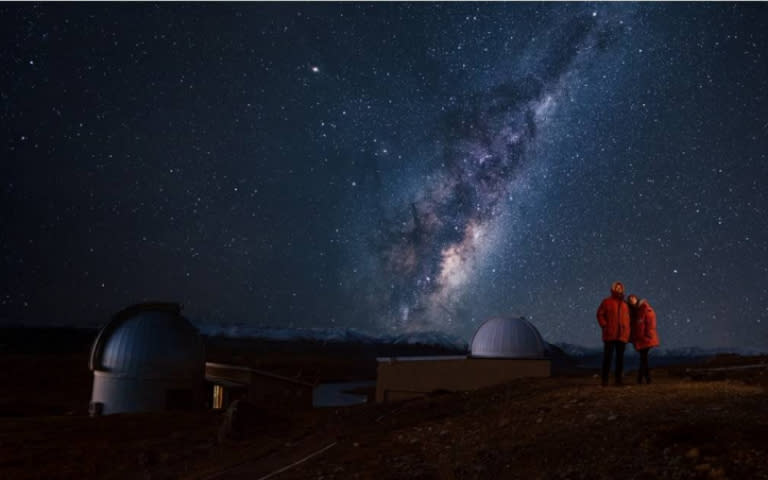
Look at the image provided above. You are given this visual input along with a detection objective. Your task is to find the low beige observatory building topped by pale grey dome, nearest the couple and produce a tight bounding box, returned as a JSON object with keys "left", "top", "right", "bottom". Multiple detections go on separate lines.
{"left": 376, "top": 317, "right": 551, "bottom": 402}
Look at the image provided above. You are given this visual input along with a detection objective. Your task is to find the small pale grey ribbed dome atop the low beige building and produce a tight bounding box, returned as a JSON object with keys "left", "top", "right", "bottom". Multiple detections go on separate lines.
{"left": 472, "top": 317, "right": 545, "bottom": 358}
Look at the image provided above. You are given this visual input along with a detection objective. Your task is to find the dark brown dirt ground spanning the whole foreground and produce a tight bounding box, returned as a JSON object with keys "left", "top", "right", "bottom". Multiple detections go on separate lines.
{"left": 0, "top": 354, "right": 768, "bottom": 480}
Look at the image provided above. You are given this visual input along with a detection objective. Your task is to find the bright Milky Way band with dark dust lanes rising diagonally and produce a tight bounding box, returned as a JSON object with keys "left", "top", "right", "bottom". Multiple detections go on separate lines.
{"left": 364, "top": 13, "right": 620, "bottom": 331}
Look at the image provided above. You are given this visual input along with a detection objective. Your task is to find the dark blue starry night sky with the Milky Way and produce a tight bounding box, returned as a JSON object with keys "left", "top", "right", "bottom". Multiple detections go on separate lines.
{"left": 0, "top": 3, "right": 768, "bottom": 347}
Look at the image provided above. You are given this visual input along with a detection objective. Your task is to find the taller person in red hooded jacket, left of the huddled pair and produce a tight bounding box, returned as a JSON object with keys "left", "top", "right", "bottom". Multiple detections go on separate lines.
{"left": 597, "top": 282, "right": 630, "bottom": 386}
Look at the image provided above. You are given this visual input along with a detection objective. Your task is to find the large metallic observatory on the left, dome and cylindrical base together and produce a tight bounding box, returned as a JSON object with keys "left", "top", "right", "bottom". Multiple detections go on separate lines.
{"left": 89, "top": 303, "right": 205, "bottom": 414}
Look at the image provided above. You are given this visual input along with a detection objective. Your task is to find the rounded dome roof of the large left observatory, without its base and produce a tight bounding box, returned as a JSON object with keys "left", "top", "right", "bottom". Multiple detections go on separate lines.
{"left": 89, "top": 303, "right": 205, "bottom": 378}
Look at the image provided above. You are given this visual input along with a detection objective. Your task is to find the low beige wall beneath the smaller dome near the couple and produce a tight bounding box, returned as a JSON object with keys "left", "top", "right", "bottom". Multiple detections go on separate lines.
{"left": 376, "top": 357, "right": 550, "bottom": 402}
